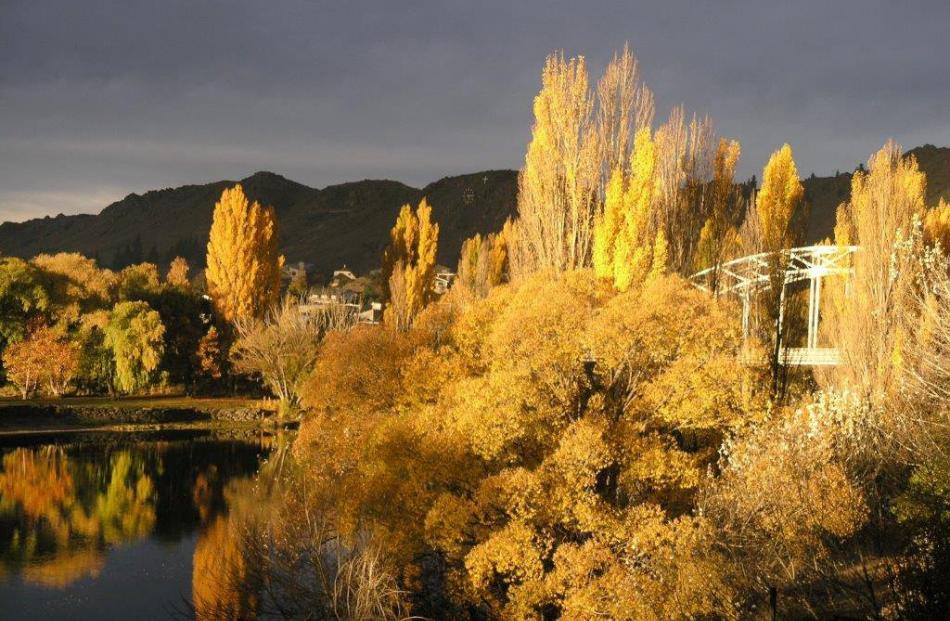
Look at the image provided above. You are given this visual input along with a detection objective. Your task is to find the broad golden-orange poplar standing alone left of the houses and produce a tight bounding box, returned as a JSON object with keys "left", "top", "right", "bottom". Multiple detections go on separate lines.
{"left": 206, "top": 184, "right": 284, "bottom": 321}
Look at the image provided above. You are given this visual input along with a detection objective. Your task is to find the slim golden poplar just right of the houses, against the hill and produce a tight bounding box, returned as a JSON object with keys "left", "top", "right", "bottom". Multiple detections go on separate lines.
{"left": 382, "top": 198, "right": 439, "bottom": 325}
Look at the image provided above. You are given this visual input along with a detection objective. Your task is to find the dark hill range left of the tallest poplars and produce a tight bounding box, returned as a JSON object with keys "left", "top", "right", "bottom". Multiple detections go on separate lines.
{"left": 0, "top": 170, "right": 517, "bottom": 274}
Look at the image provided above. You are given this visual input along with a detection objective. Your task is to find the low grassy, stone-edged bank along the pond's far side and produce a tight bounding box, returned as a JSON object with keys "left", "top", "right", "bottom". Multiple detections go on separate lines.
{"left": 0, "top": 396, "right": 278, "bottom": 435}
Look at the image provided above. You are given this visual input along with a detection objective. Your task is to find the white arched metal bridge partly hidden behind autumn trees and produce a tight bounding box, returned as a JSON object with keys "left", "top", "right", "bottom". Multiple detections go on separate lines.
{"left": 689, "top": 245, "right": 858, "bottom": 366}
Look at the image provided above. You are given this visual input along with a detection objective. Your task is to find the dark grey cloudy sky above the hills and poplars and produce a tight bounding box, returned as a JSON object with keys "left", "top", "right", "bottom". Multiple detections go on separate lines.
{"left": 0, "top": 0, "right": 950, "bottom": 221}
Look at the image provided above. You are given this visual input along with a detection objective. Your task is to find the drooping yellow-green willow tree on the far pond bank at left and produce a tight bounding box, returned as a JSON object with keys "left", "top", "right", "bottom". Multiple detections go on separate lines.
{"left": 105, "top": 301, "right": 165, "bottom": 393}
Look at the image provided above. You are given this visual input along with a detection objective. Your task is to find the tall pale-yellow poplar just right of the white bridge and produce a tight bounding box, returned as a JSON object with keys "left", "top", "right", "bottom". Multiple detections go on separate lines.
{"left": 828, "top": 142, "right": 926, "bottom": 399}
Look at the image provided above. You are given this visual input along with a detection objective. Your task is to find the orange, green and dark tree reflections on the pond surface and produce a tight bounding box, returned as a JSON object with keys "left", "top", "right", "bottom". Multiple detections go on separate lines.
{"left": 0, "top": 438, "right": 269, "bottom": 589}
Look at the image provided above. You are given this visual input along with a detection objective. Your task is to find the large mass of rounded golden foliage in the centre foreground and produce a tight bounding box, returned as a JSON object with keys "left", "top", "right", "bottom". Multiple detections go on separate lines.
{"left": 298, "top": 271, "right": 762, "bottom": 619}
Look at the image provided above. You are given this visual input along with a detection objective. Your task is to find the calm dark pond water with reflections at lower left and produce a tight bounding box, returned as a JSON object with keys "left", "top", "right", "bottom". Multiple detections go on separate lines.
{"left": 0, "top": 432, "right": 272, "bottom": 621}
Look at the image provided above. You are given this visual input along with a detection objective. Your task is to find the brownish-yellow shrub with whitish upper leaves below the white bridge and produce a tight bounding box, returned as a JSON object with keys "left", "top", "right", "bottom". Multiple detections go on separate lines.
{"left": 700, "top": 394, "right": 874, "bottom": 611}
